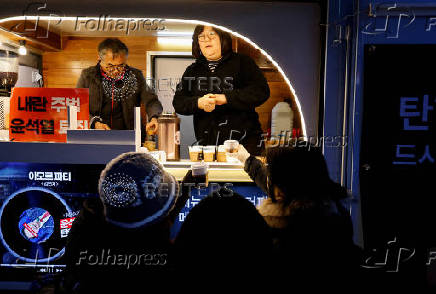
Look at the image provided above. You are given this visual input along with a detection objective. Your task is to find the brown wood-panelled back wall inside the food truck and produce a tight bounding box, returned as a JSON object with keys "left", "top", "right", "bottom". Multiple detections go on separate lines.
{"left": 43, "top": 37, "right": 301, "bottom": 131}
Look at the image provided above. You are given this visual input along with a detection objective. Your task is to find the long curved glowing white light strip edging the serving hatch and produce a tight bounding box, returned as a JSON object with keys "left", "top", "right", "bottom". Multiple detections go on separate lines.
{"left": 0, "top": 16, "right": 307, "bottom": 140}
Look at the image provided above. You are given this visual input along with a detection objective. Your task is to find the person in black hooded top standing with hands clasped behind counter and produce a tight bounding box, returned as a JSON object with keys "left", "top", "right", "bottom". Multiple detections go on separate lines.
{"left": 173, "top": 25, "right": 270, "bottom": 155}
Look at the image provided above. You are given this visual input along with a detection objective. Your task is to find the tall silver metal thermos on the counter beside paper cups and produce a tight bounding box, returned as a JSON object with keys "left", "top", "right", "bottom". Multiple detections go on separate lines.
{"left": 157, "top": 113, "right": 180, "bottom": 161}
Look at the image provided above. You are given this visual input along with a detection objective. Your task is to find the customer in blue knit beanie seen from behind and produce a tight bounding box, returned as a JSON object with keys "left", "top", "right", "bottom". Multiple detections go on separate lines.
{"left": 57, "top": 152, "right": 196, "bottom": 293}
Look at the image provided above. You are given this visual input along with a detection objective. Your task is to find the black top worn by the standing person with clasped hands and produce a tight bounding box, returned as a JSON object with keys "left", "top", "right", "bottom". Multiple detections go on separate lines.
{"left": 173, "top": 52, "right": 270, "bottom": 153}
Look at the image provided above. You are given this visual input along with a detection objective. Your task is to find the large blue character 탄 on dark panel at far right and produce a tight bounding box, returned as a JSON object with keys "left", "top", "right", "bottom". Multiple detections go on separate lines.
{"left": 400, "top": 95, "right": 434, "bottom": 131}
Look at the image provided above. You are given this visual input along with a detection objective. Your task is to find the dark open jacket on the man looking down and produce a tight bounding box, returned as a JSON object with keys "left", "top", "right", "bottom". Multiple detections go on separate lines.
{"left": 76, "top": 64, "right": 162, "bottom": 130}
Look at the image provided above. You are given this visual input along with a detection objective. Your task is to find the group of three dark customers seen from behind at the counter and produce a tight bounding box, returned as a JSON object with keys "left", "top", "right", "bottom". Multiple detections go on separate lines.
{"left": 52, "top": 147, "right": 372, "bottom": 293}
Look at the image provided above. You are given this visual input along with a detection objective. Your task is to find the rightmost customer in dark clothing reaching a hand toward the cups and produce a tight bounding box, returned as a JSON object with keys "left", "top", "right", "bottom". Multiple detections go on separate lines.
{"left": 236, "top": 142, "right": 362, "bottom": 289}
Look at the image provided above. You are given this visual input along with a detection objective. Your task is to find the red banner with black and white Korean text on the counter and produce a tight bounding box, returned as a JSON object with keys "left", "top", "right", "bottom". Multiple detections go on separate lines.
{"left": 9, "top": 88, "right": 89, "bottom": 142}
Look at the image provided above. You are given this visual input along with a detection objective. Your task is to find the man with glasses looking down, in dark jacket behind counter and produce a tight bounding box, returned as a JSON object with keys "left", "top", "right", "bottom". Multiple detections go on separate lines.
{"left": 77, "top": 38, "right": 162, "bottom": 134}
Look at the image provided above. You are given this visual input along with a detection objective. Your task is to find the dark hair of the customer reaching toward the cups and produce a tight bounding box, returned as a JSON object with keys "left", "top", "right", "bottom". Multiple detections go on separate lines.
{"left": 266, "top": 142, "right": 347, "bottom": 204}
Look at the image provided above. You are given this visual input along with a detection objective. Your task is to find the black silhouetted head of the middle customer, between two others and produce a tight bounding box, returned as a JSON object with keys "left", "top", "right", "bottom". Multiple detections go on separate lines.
{"left": 174, "top": 188, "right": 272, "bottom": 290}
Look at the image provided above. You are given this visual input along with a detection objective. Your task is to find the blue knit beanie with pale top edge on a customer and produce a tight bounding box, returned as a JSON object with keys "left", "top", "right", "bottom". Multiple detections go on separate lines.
{"left": 98, "top": 152, "right": 179, "bottom": 228}
